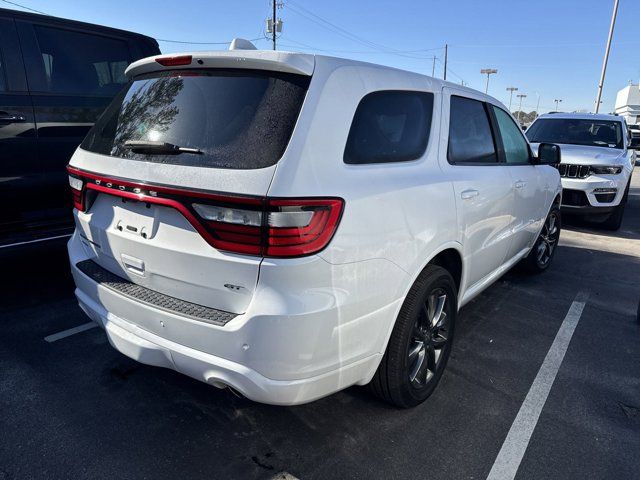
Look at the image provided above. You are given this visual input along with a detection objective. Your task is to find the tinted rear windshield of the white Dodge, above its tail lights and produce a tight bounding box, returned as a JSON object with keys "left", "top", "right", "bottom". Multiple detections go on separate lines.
{"left": 81, "top": 70, "right": 309, "bottom": 169}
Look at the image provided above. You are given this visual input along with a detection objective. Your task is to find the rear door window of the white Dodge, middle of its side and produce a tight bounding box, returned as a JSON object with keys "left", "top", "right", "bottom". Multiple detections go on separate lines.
{"left": 447, "top": 96, "right": 498, "bottom": 164}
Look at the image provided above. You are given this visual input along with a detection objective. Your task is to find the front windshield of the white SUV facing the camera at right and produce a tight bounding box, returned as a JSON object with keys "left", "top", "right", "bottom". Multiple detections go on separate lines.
{"left": 526, "top": 118, "right": 623, "bottom": 148}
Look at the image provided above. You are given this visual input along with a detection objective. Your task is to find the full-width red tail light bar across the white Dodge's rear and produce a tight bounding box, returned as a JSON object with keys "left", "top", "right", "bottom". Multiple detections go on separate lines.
{"left": 67, "top": 167, "right": 344, "bottom": 258}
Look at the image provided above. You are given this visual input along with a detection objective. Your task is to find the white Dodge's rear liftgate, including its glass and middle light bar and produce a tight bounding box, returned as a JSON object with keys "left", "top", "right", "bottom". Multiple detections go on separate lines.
{"left": 69, "top": 56, "right": 310, "bottom": 313}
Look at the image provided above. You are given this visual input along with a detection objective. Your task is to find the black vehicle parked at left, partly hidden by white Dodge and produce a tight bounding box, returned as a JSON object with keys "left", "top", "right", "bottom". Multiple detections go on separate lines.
{"left": 0, "top": 9, "right": 160, "bottom": 244}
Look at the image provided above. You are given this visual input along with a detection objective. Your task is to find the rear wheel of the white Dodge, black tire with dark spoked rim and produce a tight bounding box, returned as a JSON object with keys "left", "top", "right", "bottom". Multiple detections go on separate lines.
{"left": 369, "top": 265, "right": 458, "bottom": 408}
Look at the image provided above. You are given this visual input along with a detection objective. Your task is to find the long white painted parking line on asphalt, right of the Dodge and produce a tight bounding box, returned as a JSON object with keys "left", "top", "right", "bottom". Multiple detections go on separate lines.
{"left": 487, "top": 292, "right": 589, "bottom": 480}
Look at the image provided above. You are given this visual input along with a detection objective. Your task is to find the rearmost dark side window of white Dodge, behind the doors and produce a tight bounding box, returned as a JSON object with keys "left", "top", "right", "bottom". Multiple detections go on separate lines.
{"left": 344, "top": 90, "right": 433, "bottom": 164}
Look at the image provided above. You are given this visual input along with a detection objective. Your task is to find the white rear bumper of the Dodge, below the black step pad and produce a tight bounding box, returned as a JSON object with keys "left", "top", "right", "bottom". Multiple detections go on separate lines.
{"left": 69, "top": 233, "right": 406, "bottom": 405}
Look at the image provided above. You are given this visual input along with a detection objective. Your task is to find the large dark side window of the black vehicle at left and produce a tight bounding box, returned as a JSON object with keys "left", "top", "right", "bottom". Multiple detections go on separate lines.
{"left": 34, "top": 25, "right": 130, "bottom": 96}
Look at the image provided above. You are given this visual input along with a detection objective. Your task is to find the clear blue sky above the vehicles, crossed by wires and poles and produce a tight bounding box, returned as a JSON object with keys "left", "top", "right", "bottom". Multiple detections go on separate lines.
{"left": 6, "top": 0, "right": 640, "bottom": 112}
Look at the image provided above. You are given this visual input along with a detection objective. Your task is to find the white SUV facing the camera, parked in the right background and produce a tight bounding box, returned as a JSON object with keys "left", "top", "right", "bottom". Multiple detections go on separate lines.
{"left": 527, "top": 113, "right": 636, "bottom": 230}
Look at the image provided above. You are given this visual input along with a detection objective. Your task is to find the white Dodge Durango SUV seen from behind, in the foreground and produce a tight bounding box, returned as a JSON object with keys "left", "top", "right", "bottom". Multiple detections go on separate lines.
{"left": 68, "top": 45, "right": 561, "bottom": 407}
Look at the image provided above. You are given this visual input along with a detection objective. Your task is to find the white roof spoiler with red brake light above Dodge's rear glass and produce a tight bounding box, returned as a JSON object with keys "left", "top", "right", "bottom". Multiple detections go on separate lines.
{"left": 125, "top": 50, "right": 315, "bottom": 78}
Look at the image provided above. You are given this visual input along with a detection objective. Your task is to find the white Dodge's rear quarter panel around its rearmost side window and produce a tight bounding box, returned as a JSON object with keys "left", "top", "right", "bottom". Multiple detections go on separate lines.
{"left": 269, "top": 57, "right": 456, "bottom": 301}
